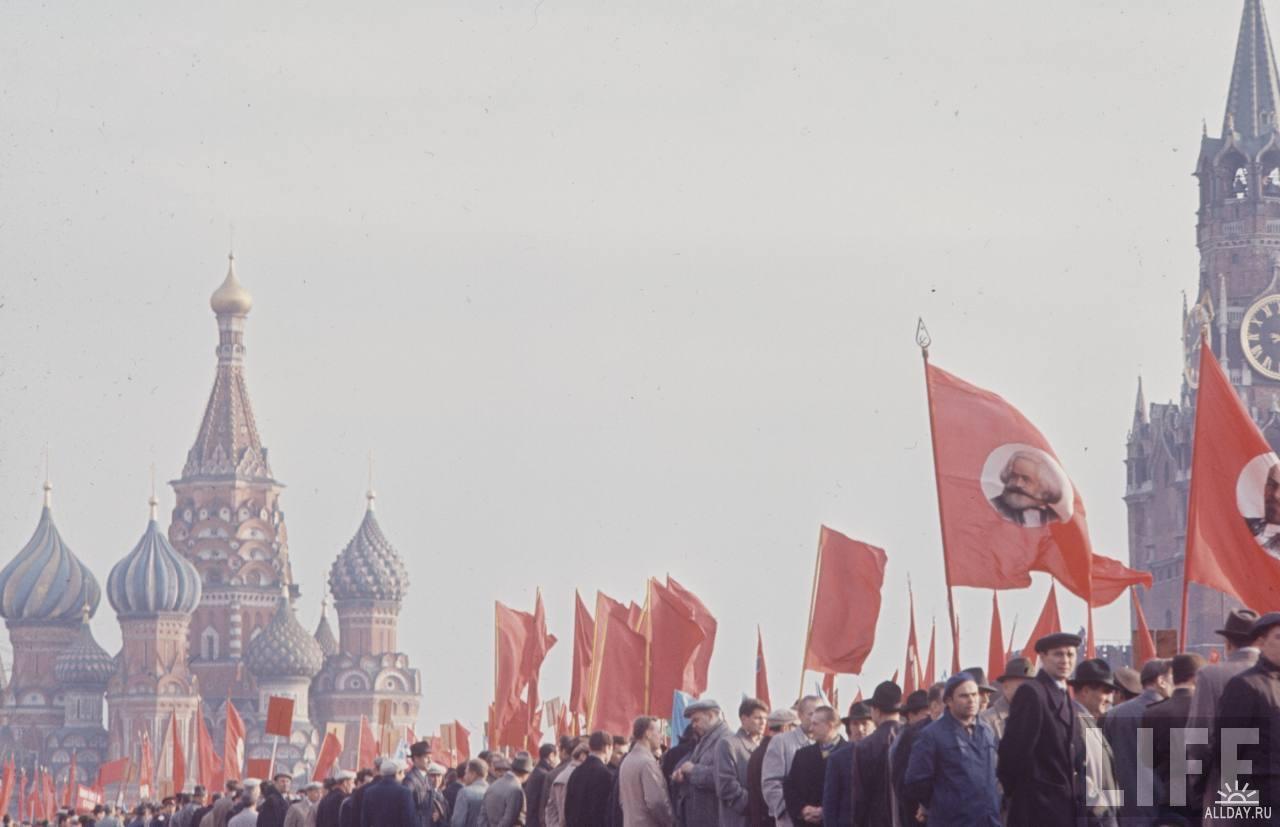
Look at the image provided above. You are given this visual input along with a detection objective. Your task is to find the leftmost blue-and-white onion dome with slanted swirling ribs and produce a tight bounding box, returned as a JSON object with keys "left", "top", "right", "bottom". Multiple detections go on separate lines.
{"left": 0, "top": 483, "right": 102, "bottom": 622}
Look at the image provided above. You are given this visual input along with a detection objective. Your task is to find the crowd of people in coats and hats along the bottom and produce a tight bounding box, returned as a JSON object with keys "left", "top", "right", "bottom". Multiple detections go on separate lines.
{"left": 4, "top": 609, "right": 1280, "bottom": 827}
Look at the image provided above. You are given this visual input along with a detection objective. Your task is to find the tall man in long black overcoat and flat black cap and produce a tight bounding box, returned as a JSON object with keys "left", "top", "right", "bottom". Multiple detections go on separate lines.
{"left": 998, "top": 632, "right": 1084, "bottom": 827}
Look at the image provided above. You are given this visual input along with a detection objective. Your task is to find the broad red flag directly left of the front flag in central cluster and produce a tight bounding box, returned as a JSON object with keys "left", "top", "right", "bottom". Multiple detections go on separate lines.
{"left": 588, "top": 612, "right": 645, "bottom": 734}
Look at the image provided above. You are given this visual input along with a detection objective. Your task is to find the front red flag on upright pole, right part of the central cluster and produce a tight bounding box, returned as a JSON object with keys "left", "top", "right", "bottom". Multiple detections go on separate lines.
{"left": 645, "top": 579, "right": 704, "bottom": 716}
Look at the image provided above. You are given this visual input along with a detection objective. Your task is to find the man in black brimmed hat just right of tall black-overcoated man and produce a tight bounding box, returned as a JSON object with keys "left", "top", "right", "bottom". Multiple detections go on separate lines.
{"left": 1068, "top": 658, "right": 1120, "bottom": 826}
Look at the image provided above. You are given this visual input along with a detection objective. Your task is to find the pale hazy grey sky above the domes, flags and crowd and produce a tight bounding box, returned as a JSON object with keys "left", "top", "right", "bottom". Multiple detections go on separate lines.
{"left": 0, "top": 0, "right": 1239, "bottom": 730}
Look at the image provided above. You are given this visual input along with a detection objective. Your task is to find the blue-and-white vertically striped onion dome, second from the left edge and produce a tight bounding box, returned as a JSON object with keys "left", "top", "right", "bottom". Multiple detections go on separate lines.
{"left": 106, "top": 497, "right": 201, "bottom": 617}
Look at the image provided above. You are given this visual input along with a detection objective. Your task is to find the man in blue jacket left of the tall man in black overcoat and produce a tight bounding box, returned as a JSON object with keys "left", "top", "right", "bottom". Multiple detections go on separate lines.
{"left": 901, "top": 672, "right": 1000, "bottom": 827}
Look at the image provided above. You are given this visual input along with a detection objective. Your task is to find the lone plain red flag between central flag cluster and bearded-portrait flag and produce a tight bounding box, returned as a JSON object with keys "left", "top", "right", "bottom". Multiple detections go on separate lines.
{"left": 804, "top": 526, "right": 886, "bottom": 675}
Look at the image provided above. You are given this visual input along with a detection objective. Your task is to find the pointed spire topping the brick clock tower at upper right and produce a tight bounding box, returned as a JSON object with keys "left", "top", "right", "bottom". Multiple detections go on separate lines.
{"left": 1222, "top": 0, "right": 1280, "bottom": 138}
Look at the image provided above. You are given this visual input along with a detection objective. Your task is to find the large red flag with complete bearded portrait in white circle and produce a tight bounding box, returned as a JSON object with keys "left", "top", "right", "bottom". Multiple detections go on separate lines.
{"left": 925, "top": 364, "right": 1092, "bottom": 599}
